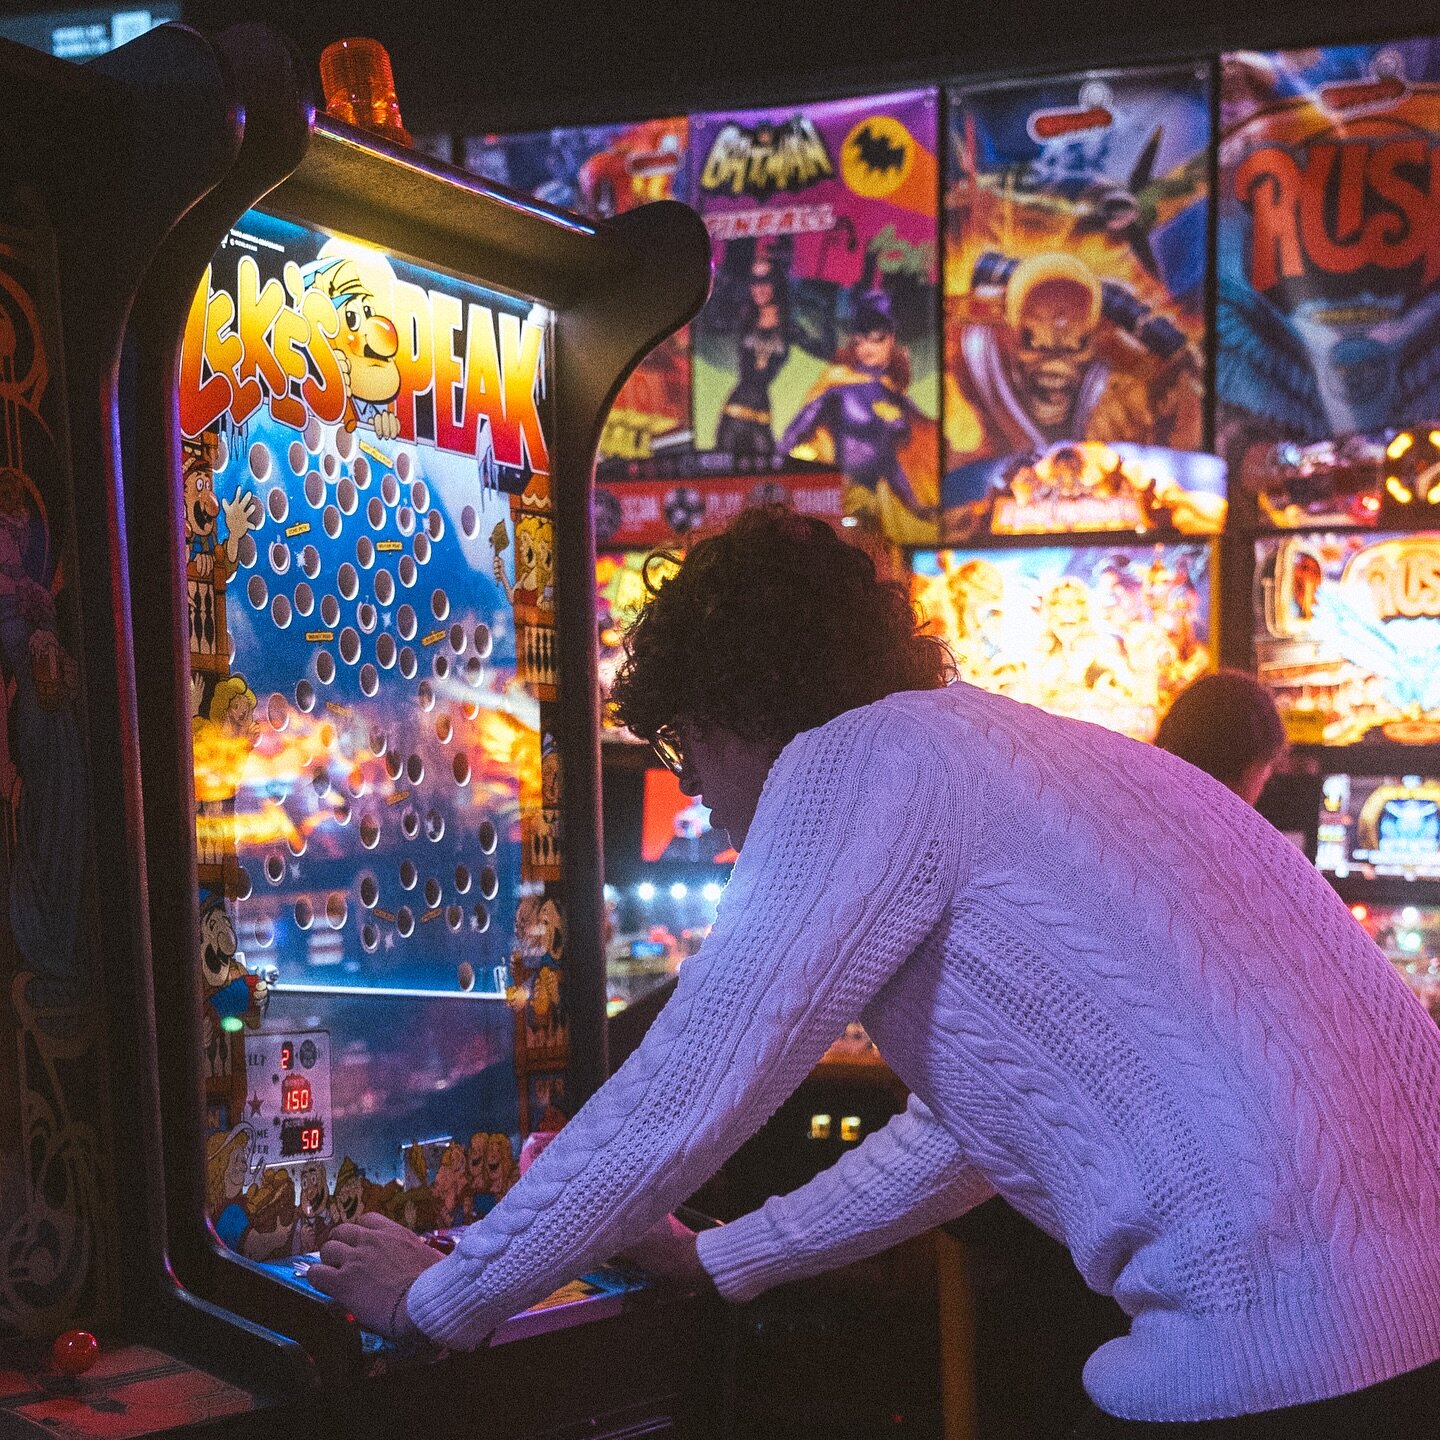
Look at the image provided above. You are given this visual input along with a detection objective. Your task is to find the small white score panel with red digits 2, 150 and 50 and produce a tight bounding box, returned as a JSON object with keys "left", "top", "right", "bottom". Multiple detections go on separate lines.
{"left": 245, "top": 1030, "right": 333, "bottom": 1165}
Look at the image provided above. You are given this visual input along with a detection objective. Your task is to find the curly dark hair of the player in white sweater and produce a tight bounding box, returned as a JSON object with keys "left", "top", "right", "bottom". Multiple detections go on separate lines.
{"left": 611, "top": 505, "right": 955, "bottom": 746}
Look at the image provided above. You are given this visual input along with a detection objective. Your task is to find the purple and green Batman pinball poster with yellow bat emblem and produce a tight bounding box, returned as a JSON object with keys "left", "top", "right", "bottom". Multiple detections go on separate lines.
{"left": 690, "top": 89, "right": 939, "bottom": 544}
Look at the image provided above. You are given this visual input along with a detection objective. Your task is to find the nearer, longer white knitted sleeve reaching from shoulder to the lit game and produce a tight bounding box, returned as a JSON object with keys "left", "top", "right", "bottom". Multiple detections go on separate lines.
{"left": 408, "top": 703, "right": 963, "bottom": 1348}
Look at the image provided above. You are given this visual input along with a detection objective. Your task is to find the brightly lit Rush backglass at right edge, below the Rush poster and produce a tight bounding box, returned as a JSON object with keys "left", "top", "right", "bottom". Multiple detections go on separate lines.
{"left": 1254, "top": 530, "right": 1440, "bottom": 744}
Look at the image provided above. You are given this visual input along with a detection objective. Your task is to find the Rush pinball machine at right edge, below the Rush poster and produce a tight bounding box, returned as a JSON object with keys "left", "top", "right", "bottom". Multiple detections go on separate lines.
{"left": 1251, "top": 429, "right": 1440, "bottom": 1018}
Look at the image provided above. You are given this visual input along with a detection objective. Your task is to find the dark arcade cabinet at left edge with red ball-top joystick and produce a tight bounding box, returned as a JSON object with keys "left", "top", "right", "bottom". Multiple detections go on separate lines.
{"left": 0, "top": 27, "right": 304, "bottom": 1436}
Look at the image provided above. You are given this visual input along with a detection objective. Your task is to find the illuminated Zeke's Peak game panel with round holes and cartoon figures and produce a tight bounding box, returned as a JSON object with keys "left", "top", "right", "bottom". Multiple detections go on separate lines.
{"left": 180, "top": 212, "right": 567, "bottom": 1260}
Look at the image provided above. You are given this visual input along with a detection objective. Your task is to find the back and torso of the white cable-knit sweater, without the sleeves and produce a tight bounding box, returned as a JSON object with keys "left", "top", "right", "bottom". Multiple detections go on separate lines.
{"left": 766, "top": 684, "right": 1440, "bottom": 1420}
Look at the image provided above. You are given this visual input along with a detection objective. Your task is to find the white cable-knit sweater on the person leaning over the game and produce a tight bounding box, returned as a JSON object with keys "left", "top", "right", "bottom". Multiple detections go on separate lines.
{"left": 408, "top": 684, "right": 1440, "bottom": 1420}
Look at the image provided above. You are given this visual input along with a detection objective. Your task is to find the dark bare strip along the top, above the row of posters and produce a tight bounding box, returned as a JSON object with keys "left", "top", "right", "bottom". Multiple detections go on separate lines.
{"left": 174, "top": 0, "right": 1440, "bottom": 134}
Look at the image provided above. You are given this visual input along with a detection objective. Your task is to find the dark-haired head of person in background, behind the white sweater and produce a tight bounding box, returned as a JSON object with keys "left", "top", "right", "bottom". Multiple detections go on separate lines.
{"left": 1155, "top": 670, "right": 1284, "bottom": 805}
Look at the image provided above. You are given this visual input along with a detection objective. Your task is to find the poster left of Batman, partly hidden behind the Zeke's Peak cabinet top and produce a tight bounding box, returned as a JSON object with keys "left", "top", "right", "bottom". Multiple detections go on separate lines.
{"left": 462, "top": 115, "right": 691, "bottom": 462}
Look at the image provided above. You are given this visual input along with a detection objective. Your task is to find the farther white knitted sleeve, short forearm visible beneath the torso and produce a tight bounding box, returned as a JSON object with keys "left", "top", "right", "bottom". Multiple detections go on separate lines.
{"left": 697, "top": 1096, "right": 995, "bottom": 1300}
